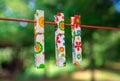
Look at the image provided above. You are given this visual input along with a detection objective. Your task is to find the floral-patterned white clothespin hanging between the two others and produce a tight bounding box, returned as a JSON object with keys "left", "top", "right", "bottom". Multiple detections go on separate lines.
{"left": 55, "top": 13, "right": 66, "bottom": 66}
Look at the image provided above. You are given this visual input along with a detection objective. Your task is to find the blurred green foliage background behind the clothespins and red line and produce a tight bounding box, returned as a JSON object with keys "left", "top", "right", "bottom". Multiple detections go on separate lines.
{"left": 0, "top": 0, "right": 120, "bottom": 81}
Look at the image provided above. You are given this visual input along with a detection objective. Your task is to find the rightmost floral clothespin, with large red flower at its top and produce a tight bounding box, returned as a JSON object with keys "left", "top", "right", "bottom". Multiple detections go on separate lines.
{"left": 71, "top": 15, "right": 82, "bottom": 66}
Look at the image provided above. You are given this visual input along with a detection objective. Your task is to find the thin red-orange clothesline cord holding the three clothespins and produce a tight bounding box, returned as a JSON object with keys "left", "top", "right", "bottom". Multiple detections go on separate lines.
{"left": 0, "top": 18, "right": 120, "bottom": 30}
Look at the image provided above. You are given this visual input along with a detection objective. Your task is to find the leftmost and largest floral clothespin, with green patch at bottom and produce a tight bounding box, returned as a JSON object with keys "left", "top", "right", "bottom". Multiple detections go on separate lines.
{"left": 34, "top": 10, "right": 45, "bottom": 68}
